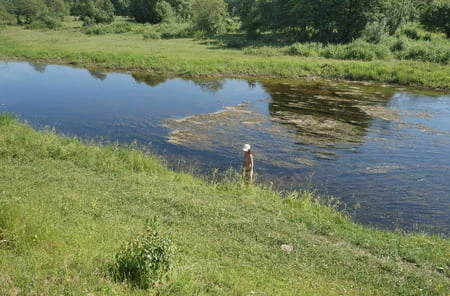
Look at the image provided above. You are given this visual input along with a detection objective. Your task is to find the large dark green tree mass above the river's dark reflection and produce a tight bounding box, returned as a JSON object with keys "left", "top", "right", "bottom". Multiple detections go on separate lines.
{"left": 242, "top": 0, "right": 376, "bottom": 43}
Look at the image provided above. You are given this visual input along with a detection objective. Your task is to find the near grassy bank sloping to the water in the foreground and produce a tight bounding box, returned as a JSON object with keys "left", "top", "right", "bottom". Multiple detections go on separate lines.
{"left": 0, "top": 115, "right": 450, "bottom": 295}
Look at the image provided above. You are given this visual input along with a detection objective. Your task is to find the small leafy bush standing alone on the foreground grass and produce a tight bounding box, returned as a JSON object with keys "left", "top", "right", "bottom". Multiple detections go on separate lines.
{"left": 113, "top": 219, "right": 172, "bottom": 289}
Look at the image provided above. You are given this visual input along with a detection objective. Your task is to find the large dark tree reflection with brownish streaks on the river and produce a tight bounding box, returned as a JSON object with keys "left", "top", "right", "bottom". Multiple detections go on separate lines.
{"left": 264, "top": 83, "right": 374, "bottom": 148}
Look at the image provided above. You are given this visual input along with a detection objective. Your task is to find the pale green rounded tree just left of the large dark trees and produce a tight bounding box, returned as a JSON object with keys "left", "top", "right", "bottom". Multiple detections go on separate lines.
{"left": 192, "top": 0, "right": 228, "bottom": 36}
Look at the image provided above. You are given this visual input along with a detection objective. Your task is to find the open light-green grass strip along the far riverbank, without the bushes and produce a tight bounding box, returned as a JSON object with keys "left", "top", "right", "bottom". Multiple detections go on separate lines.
{"left": 0, "top": 22, "right": 450, "bottom": 89}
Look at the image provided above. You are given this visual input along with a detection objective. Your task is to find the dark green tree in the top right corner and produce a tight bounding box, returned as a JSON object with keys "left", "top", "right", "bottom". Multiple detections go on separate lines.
{"left": 420, "top": 0, "right": 450, "bottom": 38}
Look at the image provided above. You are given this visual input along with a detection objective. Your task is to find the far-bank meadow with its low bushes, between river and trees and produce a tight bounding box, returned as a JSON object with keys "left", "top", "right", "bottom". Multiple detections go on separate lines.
{"left": 0, "top": 19, "right": 450, "bottom": 89}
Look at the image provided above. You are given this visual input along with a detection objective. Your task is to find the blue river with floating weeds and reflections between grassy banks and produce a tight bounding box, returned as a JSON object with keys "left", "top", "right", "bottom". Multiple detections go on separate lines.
{"left": 0, "top": 62, "right": 450, "bottom": 235}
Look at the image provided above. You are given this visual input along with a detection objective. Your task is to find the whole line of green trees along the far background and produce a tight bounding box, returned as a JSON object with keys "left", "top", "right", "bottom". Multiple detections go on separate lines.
{"left": 0, "top": 0, "right": 450, "bottom": 43}
